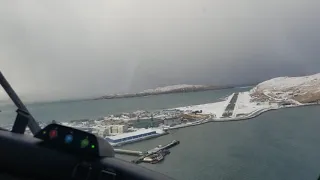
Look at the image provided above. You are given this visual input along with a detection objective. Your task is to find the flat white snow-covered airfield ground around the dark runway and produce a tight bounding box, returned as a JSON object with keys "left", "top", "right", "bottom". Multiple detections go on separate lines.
{"left": 108, "top": 91, "right": 319, "bottom": 146}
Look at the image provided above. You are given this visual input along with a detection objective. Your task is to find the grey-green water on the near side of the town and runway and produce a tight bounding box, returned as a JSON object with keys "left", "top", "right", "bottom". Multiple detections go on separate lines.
{"left": 118, "top": 106, "right": 320, "bottom": 180}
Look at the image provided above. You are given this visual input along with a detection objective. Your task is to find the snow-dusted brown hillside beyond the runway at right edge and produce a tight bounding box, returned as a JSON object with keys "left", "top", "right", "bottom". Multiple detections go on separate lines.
{"left": 250, "top": 73, "right": 320, "bottom": 103}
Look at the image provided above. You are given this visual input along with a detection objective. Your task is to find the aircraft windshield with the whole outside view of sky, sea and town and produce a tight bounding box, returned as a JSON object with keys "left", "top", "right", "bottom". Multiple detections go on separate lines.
{"left": 0, "top": 0, "right": 320, "bottom": 180}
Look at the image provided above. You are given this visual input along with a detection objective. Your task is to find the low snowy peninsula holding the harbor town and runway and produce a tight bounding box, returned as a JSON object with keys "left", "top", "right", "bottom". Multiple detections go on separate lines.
{"left": 20, "top": 82, "right": 319, "bottom": 150}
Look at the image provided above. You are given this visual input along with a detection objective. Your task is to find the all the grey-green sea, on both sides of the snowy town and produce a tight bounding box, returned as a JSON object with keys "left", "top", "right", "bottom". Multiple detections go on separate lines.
{"left": 0, "top": 89, "right": 320, "bottom": 180}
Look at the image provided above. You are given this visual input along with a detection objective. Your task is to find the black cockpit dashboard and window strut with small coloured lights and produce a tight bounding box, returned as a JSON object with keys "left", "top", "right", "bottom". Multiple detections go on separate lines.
{"left": 0, "top": 72, "right": 172, "bottom": 180}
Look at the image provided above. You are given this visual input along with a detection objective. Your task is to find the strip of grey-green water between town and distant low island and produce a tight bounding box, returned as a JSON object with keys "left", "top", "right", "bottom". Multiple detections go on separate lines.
{"left": 0, "top": 88, "right": 244, "bottom": 125}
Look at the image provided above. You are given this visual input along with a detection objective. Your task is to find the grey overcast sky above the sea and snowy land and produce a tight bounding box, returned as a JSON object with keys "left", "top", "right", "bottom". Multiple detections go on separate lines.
{"left": 0, "top": 0, "right": 320, "bottom": 100}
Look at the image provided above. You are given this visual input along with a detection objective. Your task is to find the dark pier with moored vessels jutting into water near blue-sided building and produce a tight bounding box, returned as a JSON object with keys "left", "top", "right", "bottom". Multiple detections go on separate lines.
{"left": 114, "top": 140, "right": 180, "bottom": 164}
